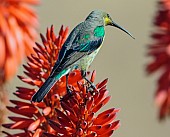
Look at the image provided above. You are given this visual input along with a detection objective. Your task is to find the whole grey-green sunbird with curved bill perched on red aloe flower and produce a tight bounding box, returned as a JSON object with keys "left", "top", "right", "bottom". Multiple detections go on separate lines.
{"left": 32, "top": 10, "right": 134, "bottom": 102}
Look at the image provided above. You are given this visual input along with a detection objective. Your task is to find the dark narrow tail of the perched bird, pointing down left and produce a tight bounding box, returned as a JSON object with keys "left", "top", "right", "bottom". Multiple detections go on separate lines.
{"left": 31, "top": 77, "right": 57, "bottom": 102}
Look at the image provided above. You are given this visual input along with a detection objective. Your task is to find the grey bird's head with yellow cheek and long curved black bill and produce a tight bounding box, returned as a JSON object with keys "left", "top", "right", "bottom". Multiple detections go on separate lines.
{"left": 86, "top": 10, "right": 134, "bottom": 38}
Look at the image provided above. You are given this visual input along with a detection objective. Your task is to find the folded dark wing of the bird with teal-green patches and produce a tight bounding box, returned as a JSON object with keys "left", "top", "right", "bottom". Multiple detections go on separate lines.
{"left": 51, "top": 23, "right": 103, "bottom": 75}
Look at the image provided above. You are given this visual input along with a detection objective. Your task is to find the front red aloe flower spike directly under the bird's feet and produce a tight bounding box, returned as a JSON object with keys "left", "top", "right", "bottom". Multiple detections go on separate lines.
{"left": 44, "top": 80, "right": 119, "bottom": 137}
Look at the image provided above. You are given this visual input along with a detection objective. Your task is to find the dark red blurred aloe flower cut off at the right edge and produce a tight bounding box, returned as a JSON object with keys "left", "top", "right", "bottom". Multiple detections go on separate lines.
{"left": 147, "top": 0, "right": 170, "bottom": 119}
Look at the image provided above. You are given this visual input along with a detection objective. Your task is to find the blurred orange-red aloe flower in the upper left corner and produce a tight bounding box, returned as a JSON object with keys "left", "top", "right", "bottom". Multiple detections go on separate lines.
{"left": 0, "top": 0, "right": 39, "bottom": 84}
